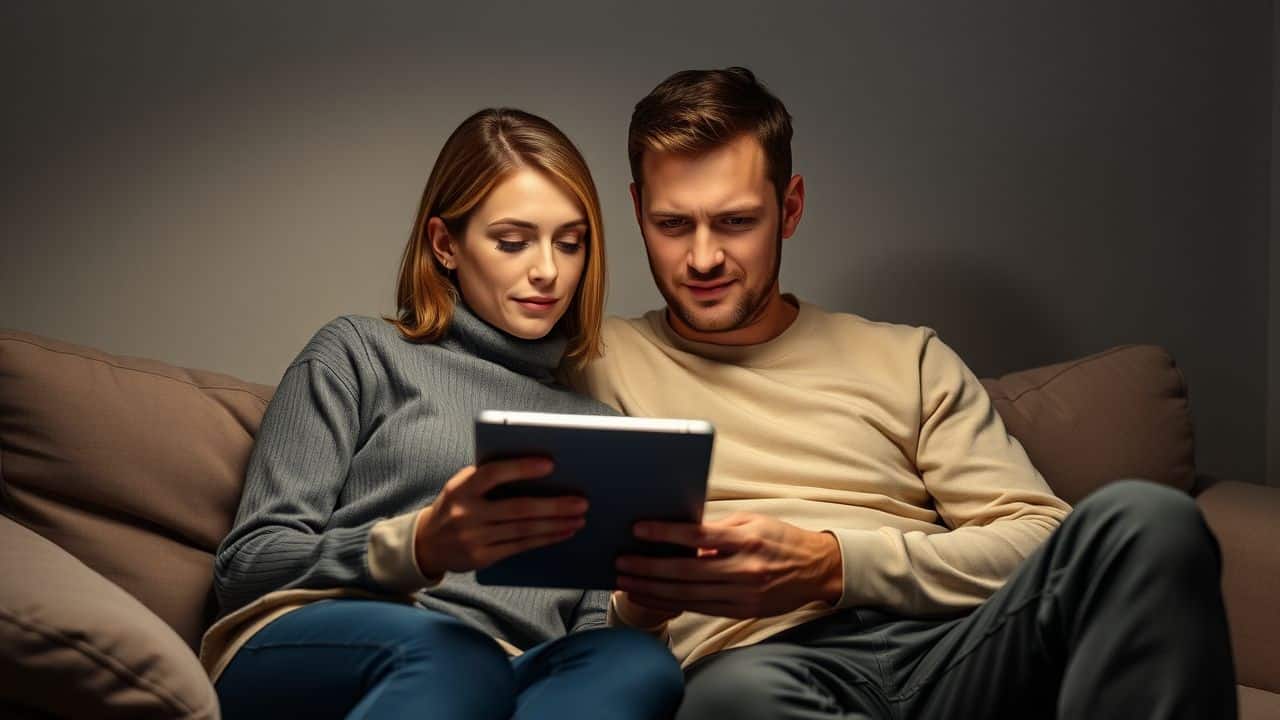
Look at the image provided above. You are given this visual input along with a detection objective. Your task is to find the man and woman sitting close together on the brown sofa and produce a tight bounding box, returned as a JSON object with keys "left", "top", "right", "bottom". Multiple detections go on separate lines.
{"left": 201, "top": 68, "right": 1235, "bottom": 720}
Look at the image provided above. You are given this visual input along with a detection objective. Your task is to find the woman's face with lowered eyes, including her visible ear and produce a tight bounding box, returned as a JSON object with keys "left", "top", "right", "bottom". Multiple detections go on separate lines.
{"left": 428, "top": 168, "right": 588, "bottom": 340}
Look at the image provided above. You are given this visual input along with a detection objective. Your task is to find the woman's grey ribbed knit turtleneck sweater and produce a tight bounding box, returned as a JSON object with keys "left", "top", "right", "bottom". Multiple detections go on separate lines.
{"left": 214, "top": 304, "right": 616, "bottom": 650}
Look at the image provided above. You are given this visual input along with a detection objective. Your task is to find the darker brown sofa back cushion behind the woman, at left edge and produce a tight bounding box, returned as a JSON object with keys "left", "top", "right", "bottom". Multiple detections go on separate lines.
{"left": 0, "top": 332, "right": 271, "bottom": 647}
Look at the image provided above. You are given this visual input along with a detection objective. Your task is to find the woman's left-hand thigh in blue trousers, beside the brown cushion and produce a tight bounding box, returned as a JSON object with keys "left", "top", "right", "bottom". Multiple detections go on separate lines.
{"left": 216, "top": 598, "right": 516, "bottom": 720}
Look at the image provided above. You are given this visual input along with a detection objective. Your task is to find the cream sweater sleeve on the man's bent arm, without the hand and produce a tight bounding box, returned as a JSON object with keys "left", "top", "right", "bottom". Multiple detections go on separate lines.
{"left": 829, "top": 329, "right": 1070, "bottom": 615}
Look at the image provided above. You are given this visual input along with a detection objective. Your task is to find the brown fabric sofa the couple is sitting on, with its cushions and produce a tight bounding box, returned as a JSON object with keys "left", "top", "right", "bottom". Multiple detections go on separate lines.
{"left": 0, "top": 326, "right": 1280, "bottom": 719}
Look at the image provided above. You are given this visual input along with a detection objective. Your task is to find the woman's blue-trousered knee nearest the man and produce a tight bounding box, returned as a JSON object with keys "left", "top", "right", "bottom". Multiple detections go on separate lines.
{"left": 511, "top": 628, "right": 685, "bottom": 720}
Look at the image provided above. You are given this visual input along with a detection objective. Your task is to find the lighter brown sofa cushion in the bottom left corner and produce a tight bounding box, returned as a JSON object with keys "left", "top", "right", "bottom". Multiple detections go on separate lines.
{"left": 0, "top": 516, "right": 218, "bottom": 719}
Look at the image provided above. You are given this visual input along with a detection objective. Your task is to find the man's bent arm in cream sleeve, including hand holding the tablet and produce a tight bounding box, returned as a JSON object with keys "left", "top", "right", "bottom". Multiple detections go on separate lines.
{"left": 618, "top": 331, "right": 1070, "bottom": 618}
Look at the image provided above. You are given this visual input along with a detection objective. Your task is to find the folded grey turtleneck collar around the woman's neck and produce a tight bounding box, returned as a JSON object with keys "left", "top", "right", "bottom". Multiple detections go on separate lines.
{"left": 440, "top": 300, "right": 568, "bottom": 382}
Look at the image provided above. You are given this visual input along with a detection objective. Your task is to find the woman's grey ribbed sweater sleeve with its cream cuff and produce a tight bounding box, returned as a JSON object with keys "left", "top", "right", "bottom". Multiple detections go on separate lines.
{"left": 214, "top": 319, "right": 431, "bottom": 614}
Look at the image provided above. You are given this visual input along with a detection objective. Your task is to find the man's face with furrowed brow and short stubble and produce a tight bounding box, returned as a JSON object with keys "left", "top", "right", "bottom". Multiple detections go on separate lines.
{"left": 631, "top": 135, "right": 799, "bottom": 333}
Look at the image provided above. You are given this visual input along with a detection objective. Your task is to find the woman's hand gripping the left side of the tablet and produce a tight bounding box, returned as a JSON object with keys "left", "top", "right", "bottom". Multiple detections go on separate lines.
{"left": 413, "top": 457, "right": 586, "bottom": 578}
